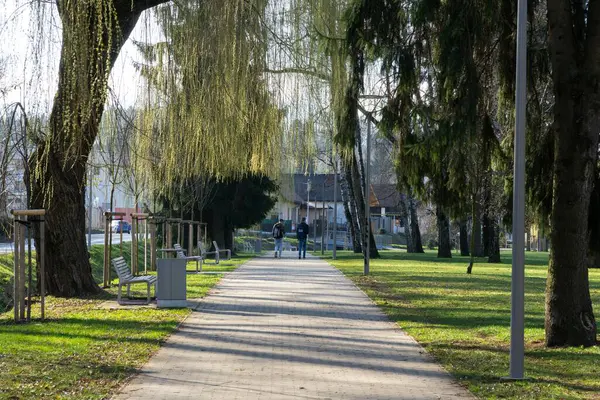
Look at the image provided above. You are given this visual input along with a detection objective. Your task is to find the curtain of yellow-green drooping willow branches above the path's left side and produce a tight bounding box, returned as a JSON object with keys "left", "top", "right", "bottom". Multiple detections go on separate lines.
{"left": 132, "top": 0, "right": 281, "bottom": 189}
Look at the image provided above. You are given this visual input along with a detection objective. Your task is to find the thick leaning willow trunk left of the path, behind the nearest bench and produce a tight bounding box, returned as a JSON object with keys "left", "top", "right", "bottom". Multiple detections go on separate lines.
{"left": 25, "top": 0, "right": 165, "bottom": 297}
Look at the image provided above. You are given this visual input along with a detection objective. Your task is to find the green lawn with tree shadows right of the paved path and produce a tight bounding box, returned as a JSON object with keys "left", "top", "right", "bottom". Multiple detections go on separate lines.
{"left": 328, "top": 251, "right": 600, "bottom": 399}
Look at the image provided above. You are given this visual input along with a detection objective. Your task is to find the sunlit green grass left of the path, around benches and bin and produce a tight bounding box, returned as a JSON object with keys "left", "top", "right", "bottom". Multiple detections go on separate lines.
{"left": 0, "top": 246, "right": 251, "bottom": 400}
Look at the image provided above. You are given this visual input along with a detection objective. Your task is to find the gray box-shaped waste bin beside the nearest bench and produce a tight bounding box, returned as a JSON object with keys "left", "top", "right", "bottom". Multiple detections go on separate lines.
{"left": 156, "top": 258, "right": 187, "bottom": 308}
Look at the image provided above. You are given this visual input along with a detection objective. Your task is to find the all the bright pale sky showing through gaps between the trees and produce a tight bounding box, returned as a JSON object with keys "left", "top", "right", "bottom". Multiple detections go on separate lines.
{"left": 0, "top": 0, "right": 381, "bottom": 135}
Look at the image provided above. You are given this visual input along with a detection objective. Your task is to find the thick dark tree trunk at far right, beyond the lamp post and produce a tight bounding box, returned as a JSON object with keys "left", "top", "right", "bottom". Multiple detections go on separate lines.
{"left": 545, "top": 0, "right": 600, "bottom": 346}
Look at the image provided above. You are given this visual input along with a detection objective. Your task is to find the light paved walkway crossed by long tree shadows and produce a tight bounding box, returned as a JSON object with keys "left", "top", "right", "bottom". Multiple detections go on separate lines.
{"left": 116, "top": 252, "right": 472, "bottom": 400}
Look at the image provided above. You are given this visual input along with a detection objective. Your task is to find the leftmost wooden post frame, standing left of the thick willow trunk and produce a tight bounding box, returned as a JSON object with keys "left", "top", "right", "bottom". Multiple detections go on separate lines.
{"left": 11, "top": 210, "right": 46, "bottom": 322}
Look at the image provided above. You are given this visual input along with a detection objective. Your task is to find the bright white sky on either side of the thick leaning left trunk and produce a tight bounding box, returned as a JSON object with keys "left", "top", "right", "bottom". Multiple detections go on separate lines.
{"left": 0, "top": 0, "right": 160, "bottom": 113}
